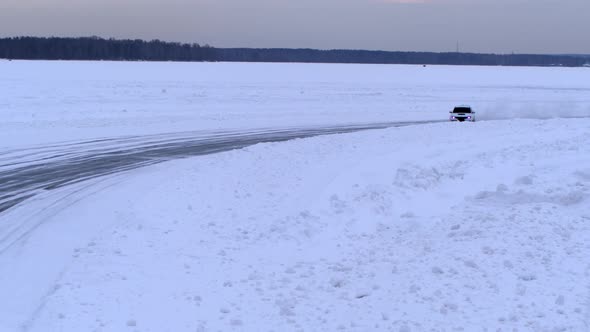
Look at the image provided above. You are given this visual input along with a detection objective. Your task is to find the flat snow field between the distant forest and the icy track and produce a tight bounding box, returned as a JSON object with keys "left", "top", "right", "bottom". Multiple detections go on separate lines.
{"left": 0, "top": 60, "right": 590, "bottom": 148}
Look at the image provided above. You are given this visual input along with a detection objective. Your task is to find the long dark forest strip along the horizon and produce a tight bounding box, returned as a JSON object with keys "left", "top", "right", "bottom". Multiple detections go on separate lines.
{"left": 0, "top": 37, "right": 590, "bottom": 67}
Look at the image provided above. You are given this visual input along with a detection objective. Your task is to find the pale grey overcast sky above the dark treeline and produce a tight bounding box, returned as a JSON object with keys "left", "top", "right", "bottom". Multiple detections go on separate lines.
{"left": 0, "top": 0, "right": 590, "bottom": 54}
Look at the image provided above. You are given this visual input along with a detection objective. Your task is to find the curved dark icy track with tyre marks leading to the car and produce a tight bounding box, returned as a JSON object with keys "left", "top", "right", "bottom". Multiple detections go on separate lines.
{"left": 0, "top": 121, "right": 437, "bottom": 212}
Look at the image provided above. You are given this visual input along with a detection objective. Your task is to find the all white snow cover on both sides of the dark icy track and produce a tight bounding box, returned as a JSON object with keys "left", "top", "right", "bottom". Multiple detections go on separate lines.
{"left": 0, "top": 61, "right": 590, "bottom": 332}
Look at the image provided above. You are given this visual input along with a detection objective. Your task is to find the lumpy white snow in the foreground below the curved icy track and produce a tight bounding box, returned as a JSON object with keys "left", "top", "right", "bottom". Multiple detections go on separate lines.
{"left": 0, "top": 119, "right": 590, "bottom": 331}
